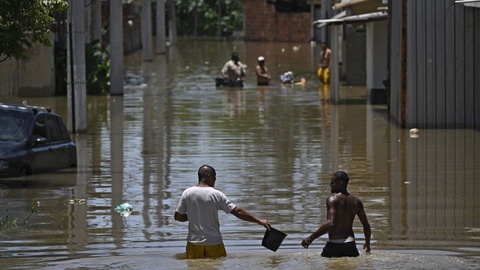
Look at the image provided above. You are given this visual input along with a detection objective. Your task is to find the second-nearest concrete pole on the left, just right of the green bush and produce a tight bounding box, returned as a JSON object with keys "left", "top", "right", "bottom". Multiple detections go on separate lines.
{"left": 109, "top": 0, "right": 123, "bottom": 96}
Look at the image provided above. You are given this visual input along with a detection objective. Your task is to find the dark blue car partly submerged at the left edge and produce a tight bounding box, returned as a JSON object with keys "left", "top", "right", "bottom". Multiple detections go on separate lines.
{"left": 0, "top": 103, "right": 77, "bottom": 177}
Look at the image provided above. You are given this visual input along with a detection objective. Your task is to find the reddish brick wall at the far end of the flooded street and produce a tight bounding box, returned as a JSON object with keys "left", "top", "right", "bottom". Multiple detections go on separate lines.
{"left": 244, "top": 0, "right": 312, "bottom": 42}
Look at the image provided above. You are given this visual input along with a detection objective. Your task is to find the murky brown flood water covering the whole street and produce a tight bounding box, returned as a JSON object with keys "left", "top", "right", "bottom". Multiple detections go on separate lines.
{"left": 0, "top": 39, "right": 480, "bottom": 269}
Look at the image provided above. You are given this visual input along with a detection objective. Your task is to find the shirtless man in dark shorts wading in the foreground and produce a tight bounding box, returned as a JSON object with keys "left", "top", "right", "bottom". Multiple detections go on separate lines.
{"left": 302, "top": 171, "right": 371, "bottom": 257}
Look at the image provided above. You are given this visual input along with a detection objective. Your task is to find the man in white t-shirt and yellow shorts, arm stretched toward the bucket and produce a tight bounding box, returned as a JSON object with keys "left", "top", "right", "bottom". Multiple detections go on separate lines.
{"left": 174, "top": 165, "right": 270, "bottom": 259}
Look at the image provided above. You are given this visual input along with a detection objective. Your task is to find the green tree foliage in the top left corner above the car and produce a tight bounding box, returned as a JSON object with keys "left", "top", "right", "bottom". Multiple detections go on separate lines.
{"left": 0, "top": 0, "right": 68, "bottom": 62}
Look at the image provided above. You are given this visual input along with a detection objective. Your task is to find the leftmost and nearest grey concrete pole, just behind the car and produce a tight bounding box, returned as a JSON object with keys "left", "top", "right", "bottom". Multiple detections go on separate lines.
{"left": 67, "top": 0, "right": 87, "bottom": 133}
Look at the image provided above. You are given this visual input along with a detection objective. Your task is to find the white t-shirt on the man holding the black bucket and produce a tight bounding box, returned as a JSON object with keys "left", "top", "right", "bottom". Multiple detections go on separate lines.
{"left": 175, "top": 186, "right": 235, "bottom": 245}
